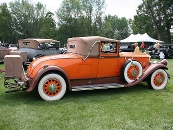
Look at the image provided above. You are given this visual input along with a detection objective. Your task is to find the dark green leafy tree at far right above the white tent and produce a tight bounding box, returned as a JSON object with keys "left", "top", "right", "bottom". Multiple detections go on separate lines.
{"left": 132, "top": 0, "right": 173, "bottom": 43}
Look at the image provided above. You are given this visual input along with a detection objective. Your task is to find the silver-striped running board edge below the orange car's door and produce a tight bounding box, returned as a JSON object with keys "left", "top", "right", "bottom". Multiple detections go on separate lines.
{"left": 72, "top": 83, "right": 124, "bottom": 91}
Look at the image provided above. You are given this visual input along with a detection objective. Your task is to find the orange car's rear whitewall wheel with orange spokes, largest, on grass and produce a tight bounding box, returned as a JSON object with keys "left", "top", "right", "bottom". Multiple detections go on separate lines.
{"left": 38, "top": 73, "right": 66, "bottom": 101}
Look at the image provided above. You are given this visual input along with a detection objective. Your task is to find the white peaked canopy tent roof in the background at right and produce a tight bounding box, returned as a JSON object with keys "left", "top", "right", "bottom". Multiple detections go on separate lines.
{"left": 120, "top": 33, "right": 163, "bottom": 43}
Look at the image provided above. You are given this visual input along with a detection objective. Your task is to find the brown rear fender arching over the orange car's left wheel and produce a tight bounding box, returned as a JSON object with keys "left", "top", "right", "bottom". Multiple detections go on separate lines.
{"left": 26, "top": 66, "right": 71, "bottom": 92}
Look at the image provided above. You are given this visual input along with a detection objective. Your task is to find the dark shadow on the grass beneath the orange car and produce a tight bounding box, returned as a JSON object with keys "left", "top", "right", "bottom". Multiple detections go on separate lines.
{"left": 0, "top": 83, "right": 158, "bottom": 105}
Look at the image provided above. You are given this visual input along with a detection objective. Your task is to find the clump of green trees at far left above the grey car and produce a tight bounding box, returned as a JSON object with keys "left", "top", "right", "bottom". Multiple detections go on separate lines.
{"left": 0, "top": 0, "right": 57, "bottom": 43}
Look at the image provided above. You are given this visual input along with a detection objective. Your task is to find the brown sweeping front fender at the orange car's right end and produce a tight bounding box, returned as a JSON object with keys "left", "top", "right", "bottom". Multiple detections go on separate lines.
{"left": 124, "top": 63, "right": 169, "bottom": 87}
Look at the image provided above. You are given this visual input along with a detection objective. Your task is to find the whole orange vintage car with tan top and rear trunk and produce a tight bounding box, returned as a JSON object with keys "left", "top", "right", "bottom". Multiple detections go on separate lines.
{"left": 0, "top": 36, "right": 169, "bottom": 101}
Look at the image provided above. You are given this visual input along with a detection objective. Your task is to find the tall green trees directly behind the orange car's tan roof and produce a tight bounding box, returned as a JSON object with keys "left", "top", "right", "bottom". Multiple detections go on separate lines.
{"left": 56, "top": 0, "right": 104, "bottom": 42}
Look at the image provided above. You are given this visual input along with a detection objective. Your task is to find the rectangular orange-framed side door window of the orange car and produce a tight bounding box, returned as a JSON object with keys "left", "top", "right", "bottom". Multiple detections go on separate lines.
{"left": 100, "top": 42, "right": 116, "bottom": 54}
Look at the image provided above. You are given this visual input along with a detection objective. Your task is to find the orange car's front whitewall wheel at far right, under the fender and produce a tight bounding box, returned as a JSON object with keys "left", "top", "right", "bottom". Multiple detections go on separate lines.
{"left": 147, "top": 69, "right": 168, "bottom": 90}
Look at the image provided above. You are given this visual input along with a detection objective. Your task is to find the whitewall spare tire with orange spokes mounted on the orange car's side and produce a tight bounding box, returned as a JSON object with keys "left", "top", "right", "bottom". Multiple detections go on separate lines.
{"left": 121, "top": 60, "right": 143, "bottom": 83}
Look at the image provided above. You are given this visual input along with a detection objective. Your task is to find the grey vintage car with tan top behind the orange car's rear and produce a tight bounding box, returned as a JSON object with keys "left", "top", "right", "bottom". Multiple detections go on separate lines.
{"left": 10, "top": 38, "right": 63, "bottom": 65}
